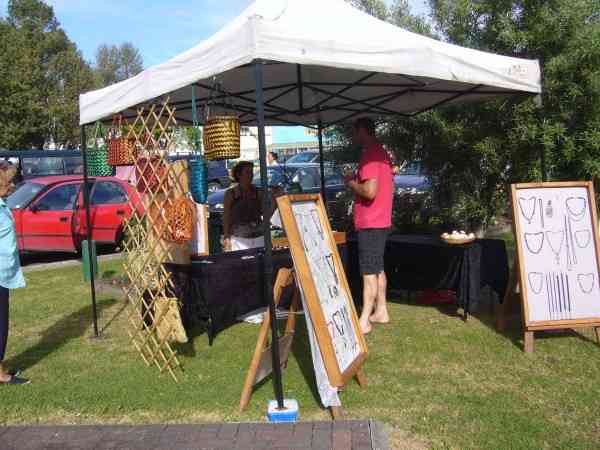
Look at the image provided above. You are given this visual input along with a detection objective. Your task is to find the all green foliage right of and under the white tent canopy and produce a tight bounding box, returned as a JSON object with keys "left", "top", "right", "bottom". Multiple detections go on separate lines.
{"left": 330, "top": 0, "right": 600, "bottom": 232}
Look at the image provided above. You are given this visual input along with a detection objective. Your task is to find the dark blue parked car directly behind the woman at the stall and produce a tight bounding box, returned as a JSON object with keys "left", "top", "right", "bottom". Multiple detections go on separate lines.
{"left": 208, "top": 164, "right": 348, "bottom": 227}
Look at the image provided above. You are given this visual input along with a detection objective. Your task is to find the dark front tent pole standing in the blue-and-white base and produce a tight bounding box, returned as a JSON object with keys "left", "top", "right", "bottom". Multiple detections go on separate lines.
{"left": 254, "top": 60, "right": 284, "bottom": 410}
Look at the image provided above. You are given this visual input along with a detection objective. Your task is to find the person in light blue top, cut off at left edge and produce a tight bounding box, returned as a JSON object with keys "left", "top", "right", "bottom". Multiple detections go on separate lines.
{"left": 0, "top": 179, "right": 29, "bottom": 385}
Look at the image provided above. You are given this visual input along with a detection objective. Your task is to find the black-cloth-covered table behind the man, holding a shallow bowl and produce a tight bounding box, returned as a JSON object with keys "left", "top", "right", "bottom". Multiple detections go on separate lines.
{"left": 348, "top": 235, "right": 508, "bottom": 316}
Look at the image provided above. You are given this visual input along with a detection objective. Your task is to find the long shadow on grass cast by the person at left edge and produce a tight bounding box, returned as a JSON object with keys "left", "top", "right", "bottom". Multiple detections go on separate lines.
{"left": 7, "top": 299, "right": 117, "bottom": 371}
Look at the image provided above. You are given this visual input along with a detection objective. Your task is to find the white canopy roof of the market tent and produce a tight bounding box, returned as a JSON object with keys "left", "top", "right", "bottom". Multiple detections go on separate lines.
{"left": 80, "top": 0, "right": 541, "bottom": 126}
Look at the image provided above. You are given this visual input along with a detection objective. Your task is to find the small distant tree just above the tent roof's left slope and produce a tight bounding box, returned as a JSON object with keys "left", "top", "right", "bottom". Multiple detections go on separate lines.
{"left": 96, "top": 42, "right": 144, "bottom": 87}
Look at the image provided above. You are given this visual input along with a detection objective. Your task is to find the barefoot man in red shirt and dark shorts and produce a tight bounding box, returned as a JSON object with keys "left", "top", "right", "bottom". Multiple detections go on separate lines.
{"left": 346, "top": 118, "right": 394, "bottom": 334}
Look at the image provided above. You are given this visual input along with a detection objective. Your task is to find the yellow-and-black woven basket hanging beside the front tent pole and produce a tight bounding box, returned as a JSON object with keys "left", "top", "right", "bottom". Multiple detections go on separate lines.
{"left": 202, "top": 116, "right": 240, "bottom": 161}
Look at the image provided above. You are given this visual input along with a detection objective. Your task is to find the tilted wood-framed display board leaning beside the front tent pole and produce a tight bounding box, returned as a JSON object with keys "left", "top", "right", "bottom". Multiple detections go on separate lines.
{"left": 277, "top": 195, "right": 367, "bottom": 387}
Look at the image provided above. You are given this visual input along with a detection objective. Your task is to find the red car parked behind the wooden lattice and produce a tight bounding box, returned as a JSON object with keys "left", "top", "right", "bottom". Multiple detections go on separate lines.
{"left": 6, "top": 176, "right": 142, "bottom": 252}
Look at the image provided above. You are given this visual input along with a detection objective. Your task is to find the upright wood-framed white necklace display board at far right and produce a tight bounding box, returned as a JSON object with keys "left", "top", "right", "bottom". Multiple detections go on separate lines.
{"left": 512, "top": 182, "right": 600, "bottom": 334}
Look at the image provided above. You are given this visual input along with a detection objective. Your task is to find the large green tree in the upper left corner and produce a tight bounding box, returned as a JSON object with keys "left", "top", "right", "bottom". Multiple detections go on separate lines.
{"left": 0, "top": 0, "right": 93, "bottom": 148}
